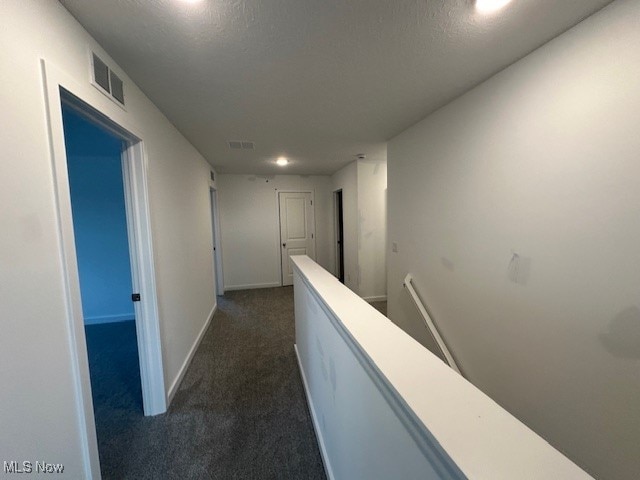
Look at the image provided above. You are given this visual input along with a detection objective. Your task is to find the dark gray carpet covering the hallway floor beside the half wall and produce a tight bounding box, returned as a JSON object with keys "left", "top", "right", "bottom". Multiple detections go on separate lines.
{"left": 85, "top": 287, "right": 326, "bottom": 480}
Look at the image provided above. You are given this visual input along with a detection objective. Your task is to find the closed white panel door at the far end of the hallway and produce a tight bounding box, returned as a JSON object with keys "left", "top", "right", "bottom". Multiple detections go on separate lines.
{"left": 278, "top": 192, "right": 316, "bottom": 286}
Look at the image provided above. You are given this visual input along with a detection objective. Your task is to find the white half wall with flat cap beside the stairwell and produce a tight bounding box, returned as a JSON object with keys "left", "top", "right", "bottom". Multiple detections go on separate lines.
{"left": 294, "top": 256, "right": 591, "bottom": 480}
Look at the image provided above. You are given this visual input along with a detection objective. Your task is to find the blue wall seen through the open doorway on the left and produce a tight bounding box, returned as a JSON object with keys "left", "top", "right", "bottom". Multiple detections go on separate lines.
{"left": 63, "top": 108, "right": 134, "bottom": 324}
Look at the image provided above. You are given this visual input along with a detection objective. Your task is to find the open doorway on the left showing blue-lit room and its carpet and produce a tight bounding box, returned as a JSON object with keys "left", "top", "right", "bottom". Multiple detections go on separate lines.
{"left": 62, "top": 103, "right": 143, "bottom": 442}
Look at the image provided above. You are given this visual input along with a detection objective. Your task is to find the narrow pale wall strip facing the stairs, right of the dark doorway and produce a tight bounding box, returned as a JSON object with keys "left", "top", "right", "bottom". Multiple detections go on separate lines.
{"left": 357, "top": 160, "right": 387, "bottom": 300}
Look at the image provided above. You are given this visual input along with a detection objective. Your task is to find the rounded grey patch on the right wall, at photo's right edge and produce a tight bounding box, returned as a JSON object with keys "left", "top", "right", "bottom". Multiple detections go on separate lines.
{"left": 599, "top": 305, "right": 640, "bottom": 359}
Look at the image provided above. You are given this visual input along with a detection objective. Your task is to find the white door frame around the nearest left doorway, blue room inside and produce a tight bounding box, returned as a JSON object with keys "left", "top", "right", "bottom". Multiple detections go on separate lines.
{"left": 40, "top": 59, "right": 167, "bottom": 478}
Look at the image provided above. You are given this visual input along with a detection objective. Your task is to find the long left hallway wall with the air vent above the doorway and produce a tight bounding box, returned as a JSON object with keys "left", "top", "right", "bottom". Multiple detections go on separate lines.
{"left": 0, "top": 0, "right": 215, "bottom": 472}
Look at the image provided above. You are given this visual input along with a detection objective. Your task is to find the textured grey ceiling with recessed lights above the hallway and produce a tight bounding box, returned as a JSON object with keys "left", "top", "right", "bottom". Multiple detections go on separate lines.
{"left": 61, "top": 0, "right": 611, "bottom": 174}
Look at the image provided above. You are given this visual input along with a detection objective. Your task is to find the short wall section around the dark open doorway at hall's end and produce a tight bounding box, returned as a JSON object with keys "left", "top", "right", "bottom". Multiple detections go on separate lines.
{"left": 330, "top": 162, "right": 360, "bottom": 294}
